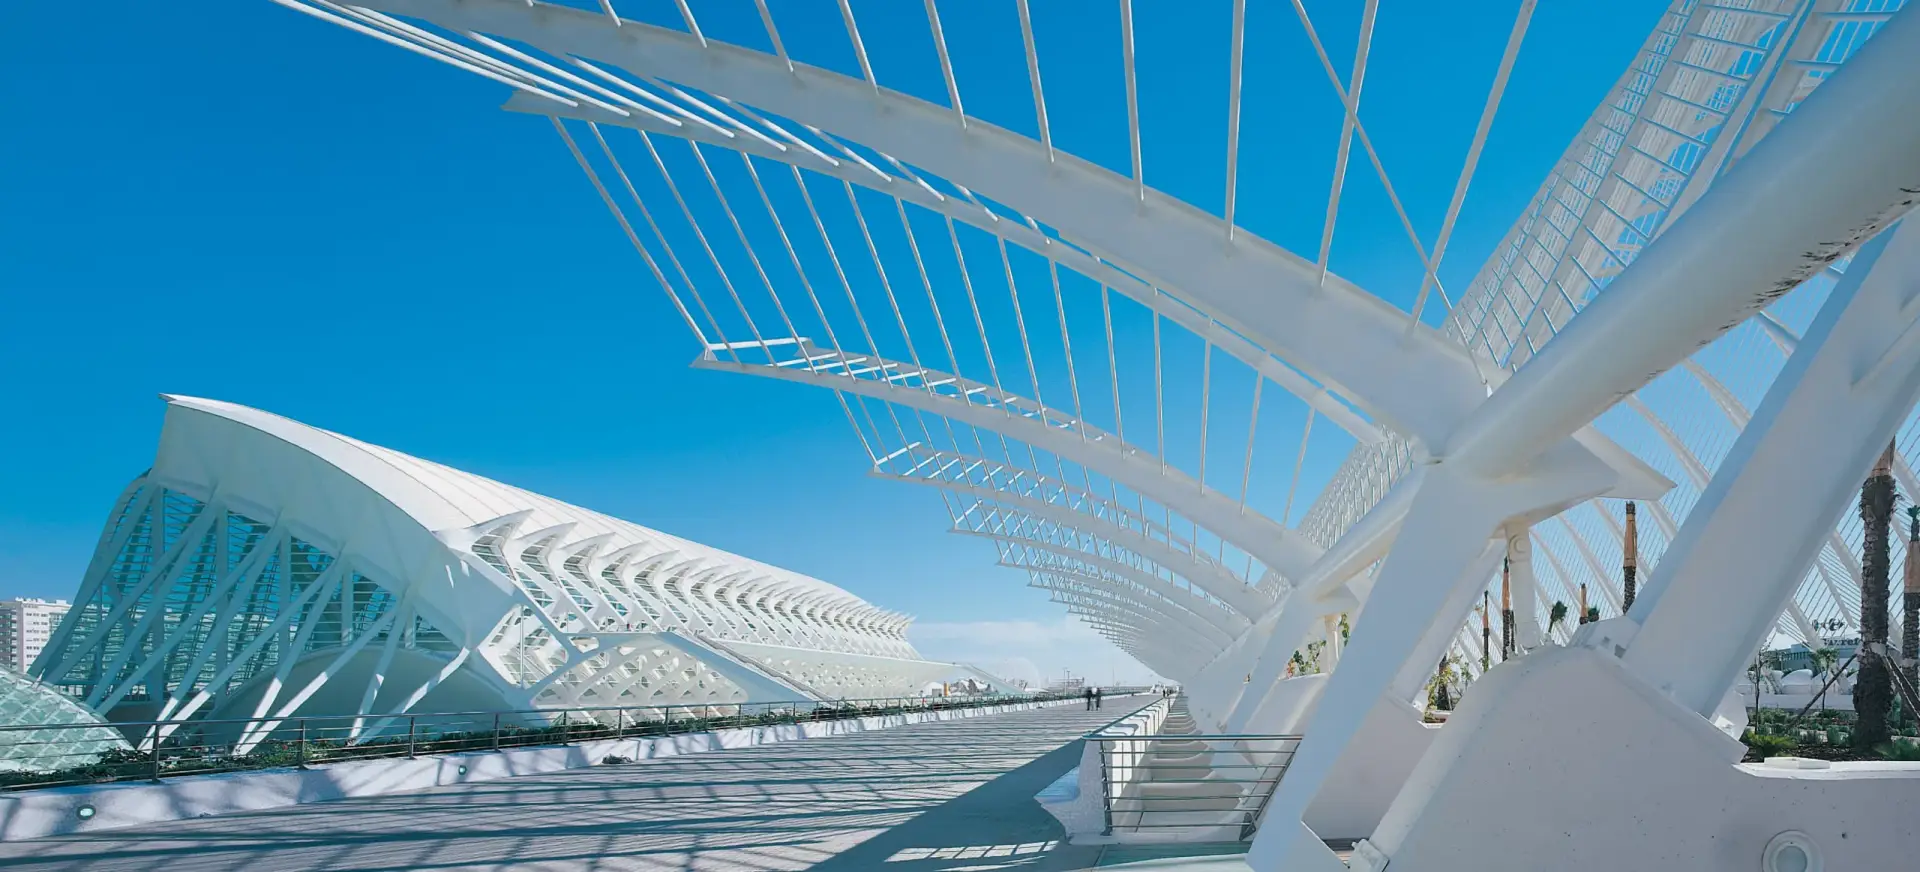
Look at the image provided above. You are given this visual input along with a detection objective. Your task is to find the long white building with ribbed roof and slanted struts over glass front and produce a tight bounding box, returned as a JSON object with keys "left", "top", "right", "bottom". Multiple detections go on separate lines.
{"left": 31, "top": 396, "right": 1000, "bottom": 741}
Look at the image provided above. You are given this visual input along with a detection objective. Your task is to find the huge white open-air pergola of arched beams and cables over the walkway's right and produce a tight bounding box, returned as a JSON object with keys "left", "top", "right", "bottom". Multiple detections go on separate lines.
{"left": 275, "top": 0, "right": 1920, "bottom": 870}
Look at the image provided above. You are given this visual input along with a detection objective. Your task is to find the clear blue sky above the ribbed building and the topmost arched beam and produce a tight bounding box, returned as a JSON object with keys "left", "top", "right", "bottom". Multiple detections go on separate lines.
{"left": 0, "top": 0, "right": 1665, "bottom": 678}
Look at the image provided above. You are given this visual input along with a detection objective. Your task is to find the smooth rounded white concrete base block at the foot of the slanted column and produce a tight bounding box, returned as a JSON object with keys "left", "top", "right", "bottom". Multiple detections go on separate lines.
{"left": 1369, "top": 647, "right": 1920, "bottom": 872}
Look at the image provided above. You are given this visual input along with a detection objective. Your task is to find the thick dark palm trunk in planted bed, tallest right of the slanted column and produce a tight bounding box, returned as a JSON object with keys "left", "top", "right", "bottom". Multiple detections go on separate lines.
{"left": 1853, "top": 442, "right": 1893, "bottom": 749}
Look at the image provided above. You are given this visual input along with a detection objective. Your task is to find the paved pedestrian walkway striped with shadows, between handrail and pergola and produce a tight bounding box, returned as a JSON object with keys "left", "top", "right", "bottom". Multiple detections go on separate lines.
{"left": 0, "top": 697, "right": 1150, "bottom": 872}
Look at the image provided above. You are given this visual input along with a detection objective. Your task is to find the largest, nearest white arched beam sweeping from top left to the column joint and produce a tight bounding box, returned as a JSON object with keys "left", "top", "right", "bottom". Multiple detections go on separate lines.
{"left": 357, "top": 0, "right": 1486, "bottom": 444}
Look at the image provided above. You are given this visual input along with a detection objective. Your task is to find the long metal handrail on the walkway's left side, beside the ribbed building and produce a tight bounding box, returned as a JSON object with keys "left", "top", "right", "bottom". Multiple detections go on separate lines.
{"left": 0, "top": 693, "right": 1068, "bottom": 791}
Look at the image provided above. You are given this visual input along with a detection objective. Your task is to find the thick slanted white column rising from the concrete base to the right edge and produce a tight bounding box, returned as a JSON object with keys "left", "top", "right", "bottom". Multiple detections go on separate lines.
{"left": 1624, "top": 221, "right": 1920, "bottom": 716}
